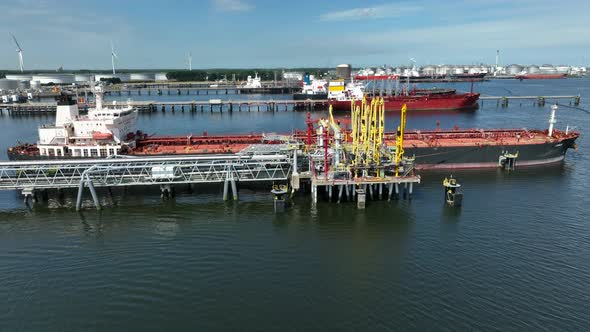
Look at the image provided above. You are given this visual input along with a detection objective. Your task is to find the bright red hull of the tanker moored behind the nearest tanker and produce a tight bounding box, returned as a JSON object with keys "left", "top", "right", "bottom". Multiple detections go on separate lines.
{"left": 330, "top": 93, "right": 479, "bottom": 111}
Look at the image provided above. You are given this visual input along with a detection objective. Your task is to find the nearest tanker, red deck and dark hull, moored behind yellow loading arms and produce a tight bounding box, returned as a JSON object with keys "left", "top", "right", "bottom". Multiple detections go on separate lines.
{"left": 8, "top": 94, "right": 580, "bottom": 169}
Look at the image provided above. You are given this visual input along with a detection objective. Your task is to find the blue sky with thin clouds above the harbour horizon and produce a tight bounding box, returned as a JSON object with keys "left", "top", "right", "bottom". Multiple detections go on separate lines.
{"left": 0, "top": 0, "right": 590, "bottom": 69}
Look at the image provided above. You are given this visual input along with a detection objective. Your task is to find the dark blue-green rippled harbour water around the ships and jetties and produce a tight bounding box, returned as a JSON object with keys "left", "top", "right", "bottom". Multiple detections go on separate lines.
{"left": 0, "top": 79, "right": 590, "bottom": 331}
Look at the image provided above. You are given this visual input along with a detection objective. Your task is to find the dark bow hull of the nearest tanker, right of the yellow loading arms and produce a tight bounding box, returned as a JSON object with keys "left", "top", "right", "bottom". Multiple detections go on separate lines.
{"left": 404, "top": 138, "right": 576, "bottom": 169}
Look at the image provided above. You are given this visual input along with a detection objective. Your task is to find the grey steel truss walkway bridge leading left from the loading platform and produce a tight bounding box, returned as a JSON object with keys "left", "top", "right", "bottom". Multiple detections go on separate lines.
{"left": 0, "top": 152, "right": 292, "bottom": 210}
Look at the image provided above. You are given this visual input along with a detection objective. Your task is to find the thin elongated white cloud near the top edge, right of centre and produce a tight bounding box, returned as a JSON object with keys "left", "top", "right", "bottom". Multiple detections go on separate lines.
{"left": 320, "top": 4, "right": 422, "bottom": 21}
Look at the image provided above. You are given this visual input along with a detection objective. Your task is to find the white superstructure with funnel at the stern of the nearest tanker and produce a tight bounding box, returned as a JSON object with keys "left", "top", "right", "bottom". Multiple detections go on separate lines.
{"left": 37, "top": 86, "right": 137, "bottom": 158}
